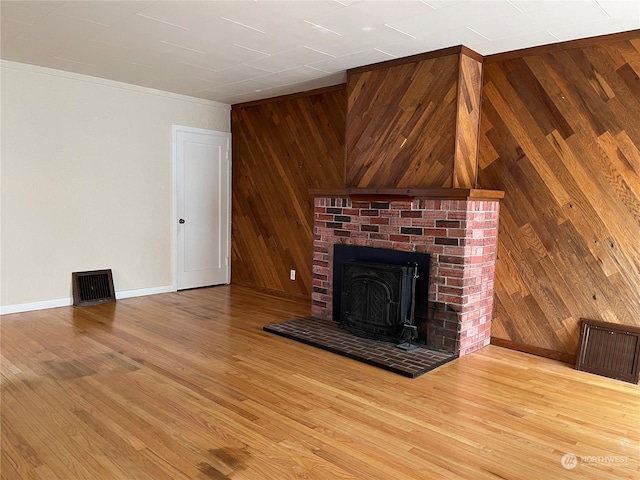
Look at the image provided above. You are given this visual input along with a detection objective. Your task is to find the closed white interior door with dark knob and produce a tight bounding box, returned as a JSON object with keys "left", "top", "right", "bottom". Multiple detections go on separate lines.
{"left": 173, "top": 126, "right": 231, "bottom": 290}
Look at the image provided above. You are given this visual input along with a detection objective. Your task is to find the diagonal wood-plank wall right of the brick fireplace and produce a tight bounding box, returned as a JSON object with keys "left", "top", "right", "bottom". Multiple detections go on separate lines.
{"left": 479, "top": 33, "right": 640, "bottom": 355}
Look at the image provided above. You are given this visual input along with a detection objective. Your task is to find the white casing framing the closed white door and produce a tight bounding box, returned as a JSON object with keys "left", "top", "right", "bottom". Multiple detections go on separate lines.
{"left": 171, "top": 125, "right": 233, "bottom": 292}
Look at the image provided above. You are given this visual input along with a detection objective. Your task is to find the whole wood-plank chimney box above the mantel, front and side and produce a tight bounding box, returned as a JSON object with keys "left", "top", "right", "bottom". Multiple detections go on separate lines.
{"left": 345, "top": 46, "right": 482, "bottom": 188}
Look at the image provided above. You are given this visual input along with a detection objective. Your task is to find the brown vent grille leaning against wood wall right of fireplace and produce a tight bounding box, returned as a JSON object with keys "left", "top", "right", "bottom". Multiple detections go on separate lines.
{"left": 576, "top": 318, "right": 640, "bottom": 384}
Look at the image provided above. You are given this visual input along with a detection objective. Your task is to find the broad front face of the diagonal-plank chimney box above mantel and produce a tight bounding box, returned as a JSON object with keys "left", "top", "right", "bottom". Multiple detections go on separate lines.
{"left": 345, "top": 53, "right": 460, "bottom": 188}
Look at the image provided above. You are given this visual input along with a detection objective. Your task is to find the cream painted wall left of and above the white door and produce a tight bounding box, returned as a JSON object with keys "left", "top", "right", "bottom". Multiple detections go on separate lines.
{"left": 0, "top": 61, "right": 231, "bottom": 313}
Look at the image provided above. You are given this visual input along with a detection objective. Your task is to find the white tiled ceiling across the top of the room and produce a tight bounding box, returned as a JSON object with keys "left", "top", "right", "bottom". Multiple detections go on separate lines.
{"left": 0, "top": 0, "right": 640, "bottom": 104}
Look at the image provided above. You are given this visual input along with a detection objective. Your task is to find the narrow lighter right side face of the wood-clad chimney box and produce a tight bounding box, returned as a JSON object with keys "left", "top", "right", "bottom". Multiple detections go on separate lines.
{"left": 453, "top": 53, "right": 482, "bottom": 188}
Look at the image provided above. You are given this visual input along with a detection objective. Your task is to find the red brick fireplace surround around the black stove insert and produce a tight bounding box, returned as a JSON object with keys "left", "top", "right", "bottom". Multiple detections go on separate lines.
{"left": 311, "top": 197, "right": 500, "bottom": 356}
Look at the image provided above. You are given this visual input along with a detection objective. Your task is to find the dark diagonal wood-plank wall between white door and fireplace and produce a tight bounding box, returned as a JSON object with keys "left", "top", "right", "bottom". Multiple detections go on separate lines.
{"left": 231, "top": 86, "right": 347, "bottom": 296}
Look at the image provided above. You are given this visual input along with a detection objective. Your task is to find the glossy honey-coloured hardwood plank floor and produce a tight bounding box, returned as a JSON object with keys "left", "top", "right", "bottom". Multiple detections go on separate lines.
{"left": 0, "top": 286, "right": 640, "bottom": 480}
